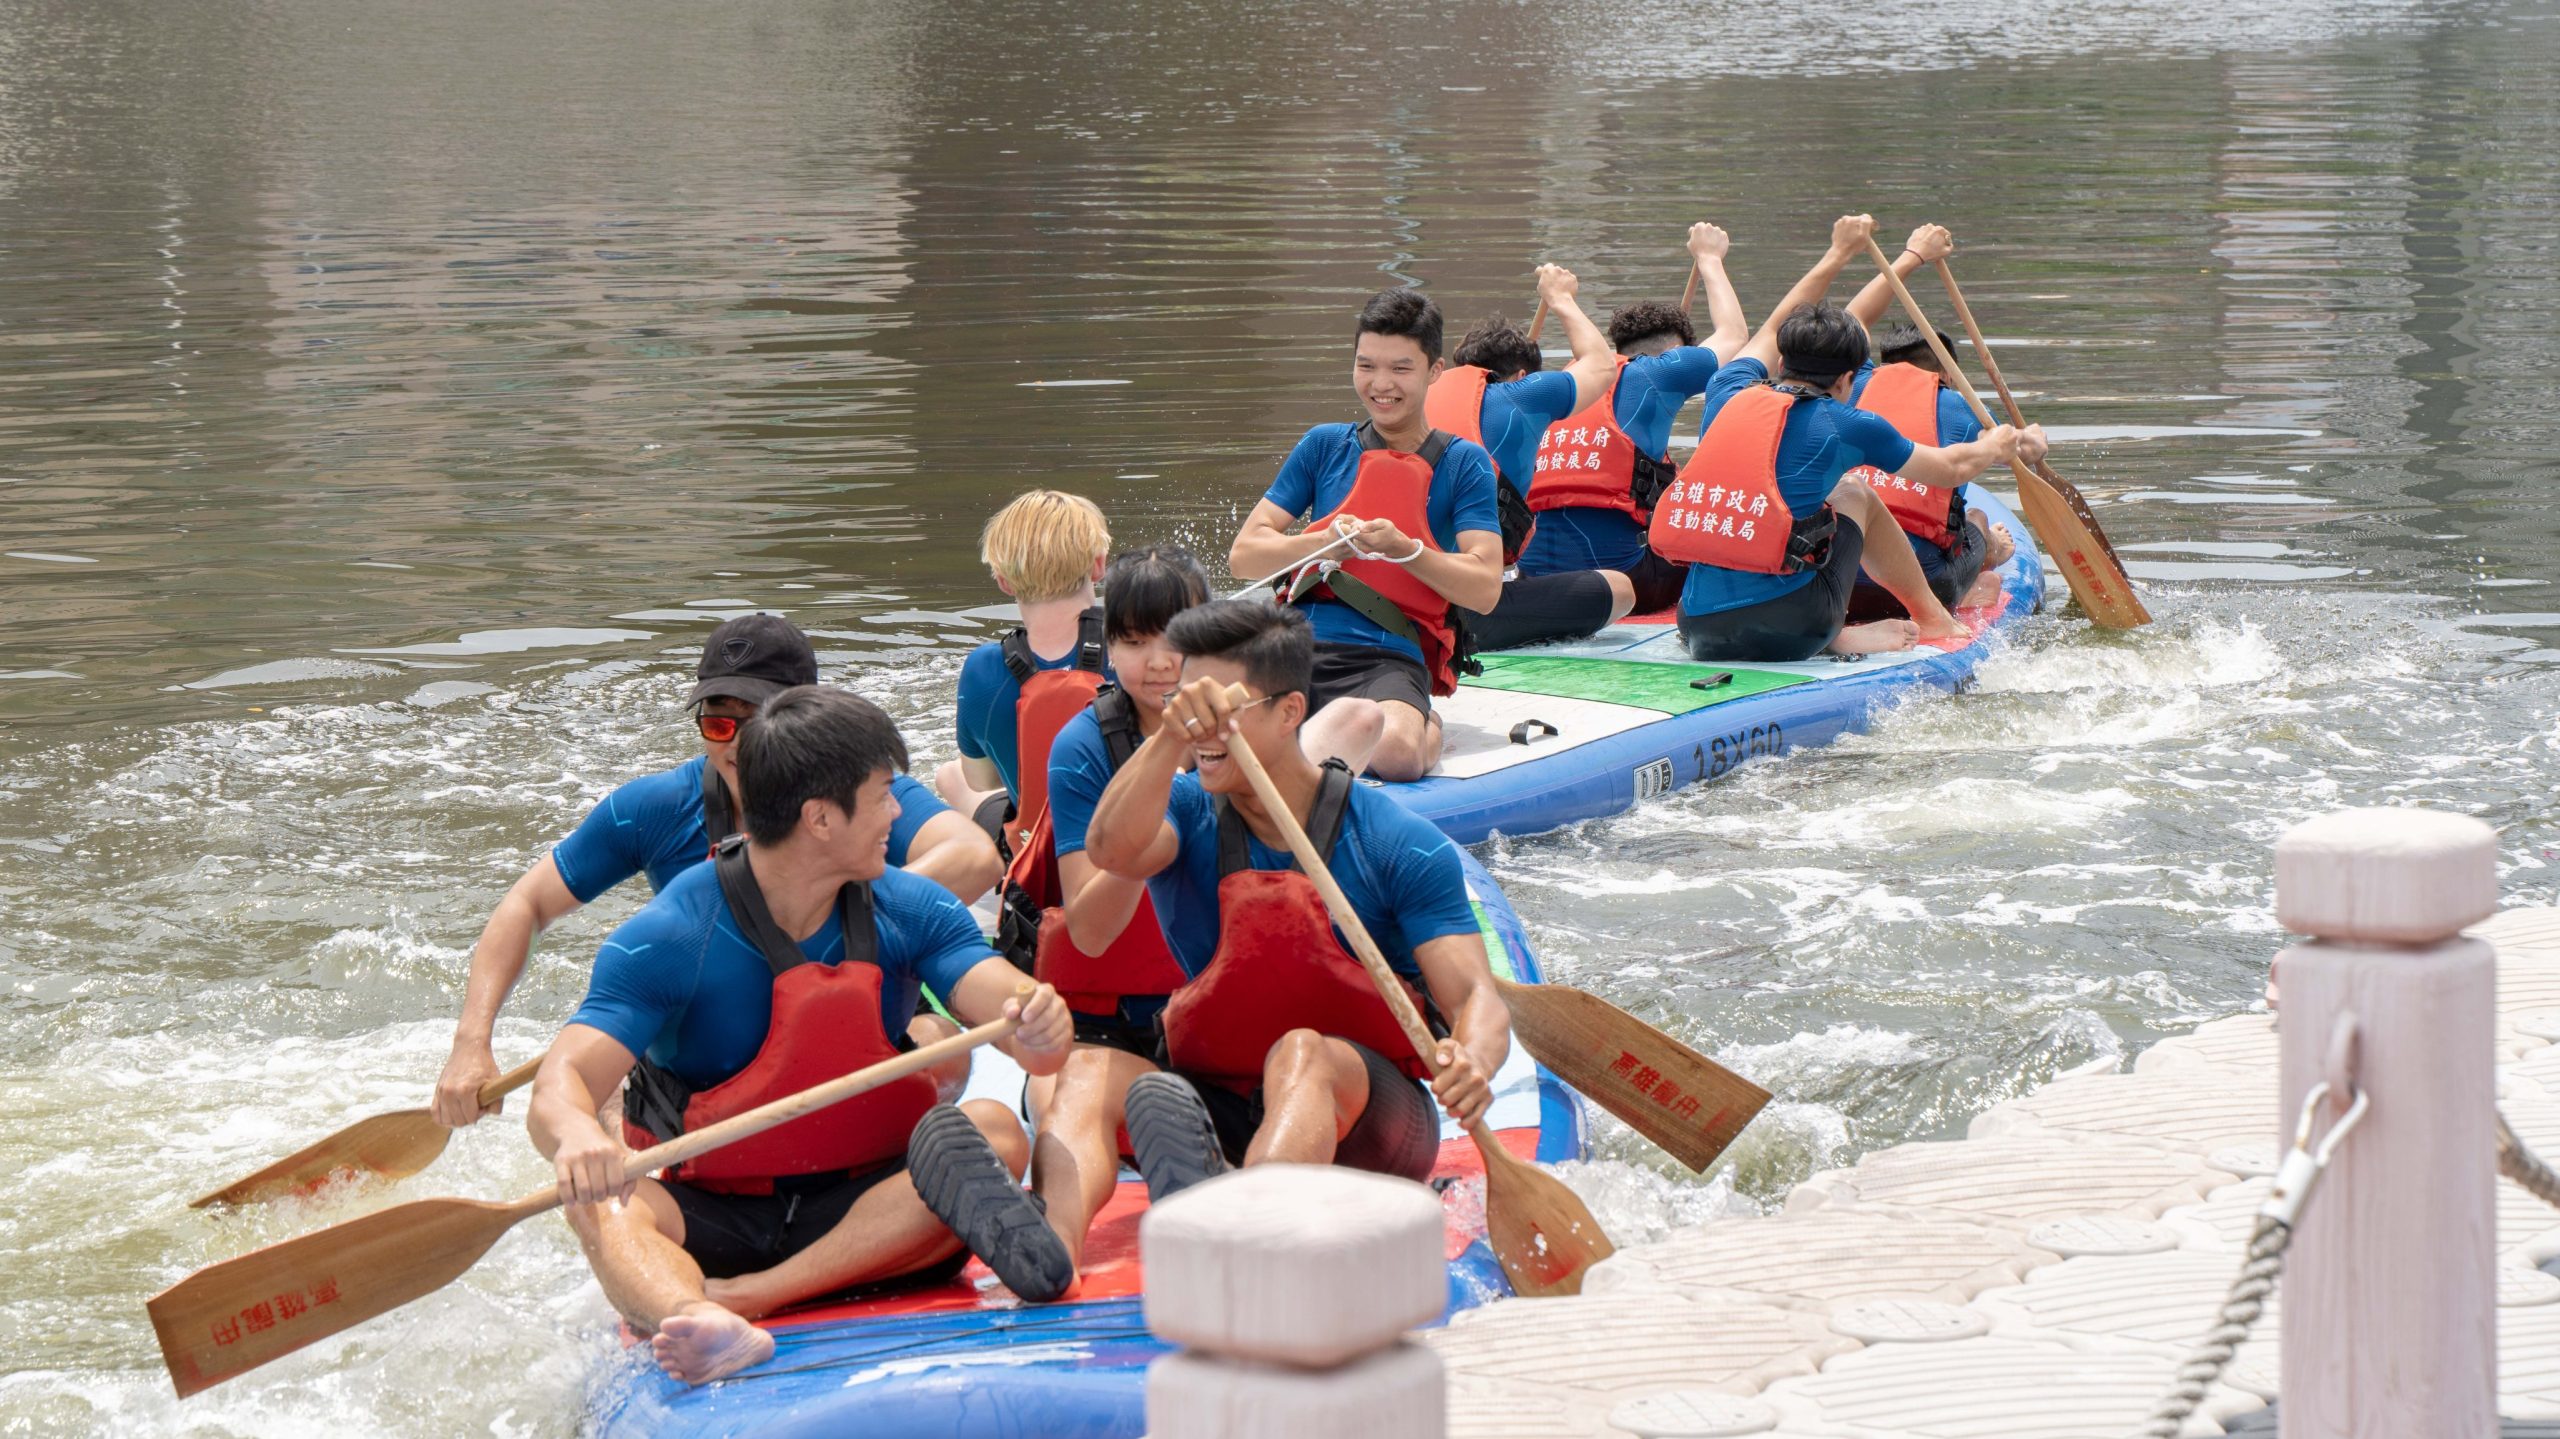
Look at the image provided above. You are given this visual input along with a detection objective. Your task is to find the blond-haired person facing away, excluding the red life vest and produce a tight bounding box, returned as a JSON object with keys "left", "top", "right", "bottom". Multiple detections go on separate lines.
{"left": 934, "top": 489, "right": 1111, "bottom": 834}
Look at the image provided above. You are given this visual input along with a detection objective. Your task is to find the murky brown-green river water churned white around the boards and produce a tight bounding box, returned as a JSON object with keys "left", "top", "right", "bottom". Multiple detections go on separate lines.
{"left": 0, "top": 0, "right": 2560, "bottom": 1436}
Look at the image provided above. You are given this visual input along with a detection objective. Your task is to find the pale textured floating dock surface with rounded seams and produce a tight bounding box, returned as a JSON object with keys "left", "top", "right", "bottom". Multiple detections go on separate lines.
{"left": 1426, "top": 909, "right": 2560, "bottom": 1439}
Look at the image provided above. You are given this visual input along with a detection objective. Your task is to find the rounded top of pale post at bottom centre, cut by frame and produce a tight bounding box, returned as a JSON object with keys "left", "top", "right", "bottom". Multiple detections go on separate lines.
{"left": 1139, "top": 1165, "right": 1449, "bottom": 1439}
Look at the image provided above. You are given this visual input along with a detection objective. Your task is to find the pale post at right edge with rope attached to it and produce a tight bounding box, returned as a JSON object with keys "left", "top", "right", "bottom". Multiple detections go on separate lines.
{"left": 2276, "top": 809, "right": 2499, "bottom": 1439}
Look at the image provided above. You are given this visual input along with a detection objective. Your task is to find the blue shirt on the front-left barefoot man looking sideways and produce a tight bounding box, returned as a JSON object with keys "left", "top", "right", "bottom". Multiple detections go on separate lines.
{"left": 568, "top": 865, "right": 993, "bottom": 1088}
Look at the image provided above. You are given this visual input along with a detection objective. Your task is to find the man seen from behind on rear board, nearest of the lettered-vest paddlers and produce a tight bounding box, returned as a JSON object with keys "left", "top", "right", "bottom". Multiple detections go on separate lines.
{"left": 1646, "top": 215, "right": 2045, "bottom": 663}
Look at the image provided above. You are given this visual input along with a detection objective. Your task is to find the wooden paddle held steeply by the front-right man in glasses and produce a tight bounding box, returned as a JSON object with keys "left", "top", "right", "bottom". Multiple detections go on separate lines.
{"left": 1226, "top": 686, "right": 1618, "bottom": 1298}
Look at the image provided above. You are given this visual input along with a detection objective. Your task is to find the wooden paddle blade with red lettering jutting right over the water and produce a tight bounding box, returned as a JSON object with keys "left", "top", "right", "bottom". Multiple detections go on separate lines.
{"left": 1495, "top": 981, "right": 1769, "bottom": 1173}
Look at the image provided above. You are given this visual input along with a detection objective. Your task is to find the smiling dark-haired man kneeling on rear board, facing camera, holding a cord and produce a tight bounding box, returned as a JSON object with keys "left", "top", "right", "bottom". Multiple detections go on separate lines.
{"left": 1226, "top": 289, "right": 1503, "bottom": 781}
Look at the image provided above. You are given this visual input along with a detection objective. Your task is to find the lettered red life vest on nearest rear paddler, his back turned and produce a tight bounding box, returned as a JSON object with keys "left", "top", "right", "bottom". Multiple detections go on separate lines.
{"left": 1644, "top": 384, "right": 1838, "bottom": 574}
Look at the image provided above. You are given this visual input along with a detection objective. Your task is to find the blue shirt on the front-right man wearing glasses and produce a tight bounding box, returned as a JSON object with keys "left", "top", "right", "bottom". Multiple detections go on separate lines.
{"left": 1147, "top": 773, "right": 1480, "bottom": 983}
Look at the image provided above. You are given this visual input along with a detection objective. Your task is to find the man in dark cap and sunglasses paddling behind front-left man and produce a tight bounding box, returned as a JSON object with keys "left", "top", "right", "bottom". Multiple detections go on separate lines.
{"left": 433, "top": 615, "right": 1004, "bottom": 1127}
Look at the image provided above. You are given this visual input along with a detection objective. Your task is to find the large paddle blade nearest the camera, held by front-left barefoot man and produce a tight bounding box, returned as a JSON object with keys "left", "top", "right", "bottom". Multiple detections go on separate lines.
{"left": 148, "top": 1191, "right": 550, "bottom": 1398}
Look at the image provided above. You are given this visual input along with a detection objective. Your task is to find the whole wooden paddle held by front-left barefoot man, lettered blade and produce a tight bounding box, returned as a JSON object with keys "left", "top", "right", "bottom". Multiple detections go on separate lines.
{"left": 148, "top": 1019, "right": 1019, "bottom": 1398}
